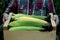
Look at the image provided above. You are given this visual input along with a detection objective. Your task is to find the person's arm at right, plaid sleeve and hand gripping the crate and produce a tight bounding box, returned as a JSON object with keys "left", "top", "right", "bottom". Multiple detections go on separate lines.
{"left": 49, "top": 0, "right": 59, "bottom": 26}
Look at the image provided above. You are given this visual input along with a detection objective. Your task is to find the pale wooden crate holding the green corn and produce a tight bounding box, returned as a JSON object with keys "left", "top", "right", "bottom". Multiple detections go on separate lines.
{"left": 3, "top": 13, "right": 56, "bottom": 40}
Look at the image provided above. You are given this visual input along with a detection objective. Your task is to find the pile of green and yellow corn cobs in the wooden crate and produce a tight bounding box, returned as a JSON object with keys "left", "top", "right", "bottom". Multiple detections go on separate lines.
{"left": 9, "top": 14, "right": 51, "bottom": 31}
